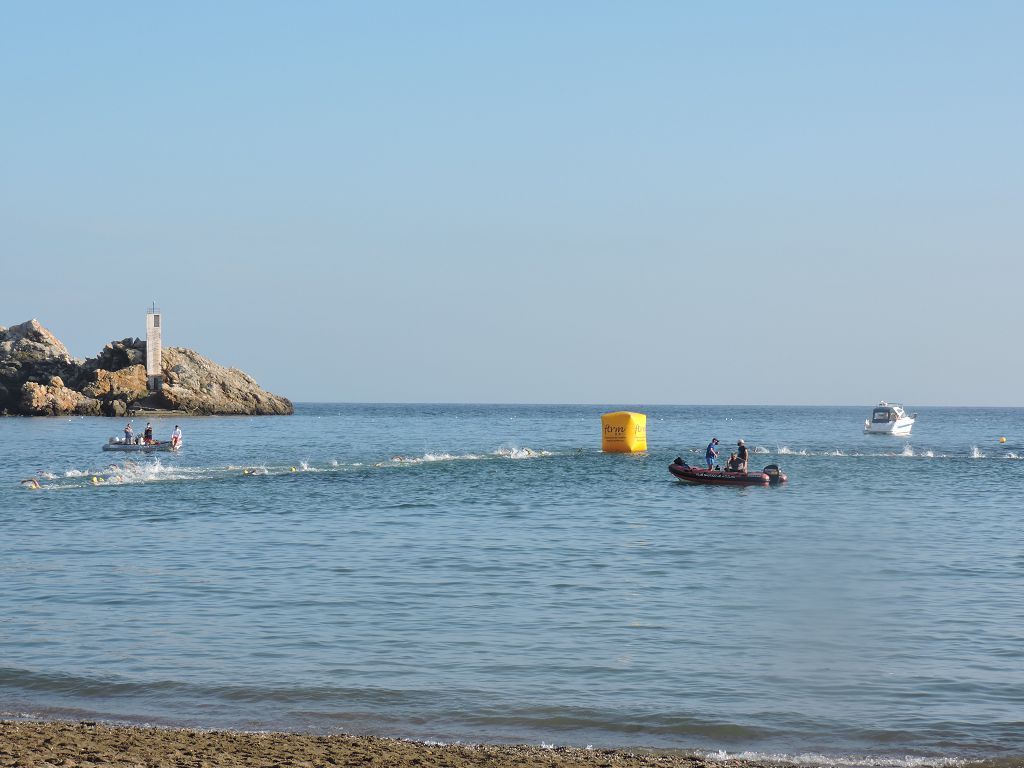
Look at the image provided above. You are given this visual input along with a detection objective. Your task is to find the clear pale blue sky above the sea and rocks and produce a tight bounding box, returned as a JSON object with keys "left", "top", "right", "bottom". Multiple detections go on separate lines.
{"left": 0, "top": 2, "right": 1024, "bottom": 406}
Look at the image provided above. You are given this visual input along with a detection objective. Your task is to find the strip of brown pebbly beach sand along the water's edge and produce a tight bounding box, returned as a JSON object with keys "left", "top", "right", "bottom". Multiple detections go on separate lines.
{"left": 0, "top": 721, "right": 811, "bottom": 768}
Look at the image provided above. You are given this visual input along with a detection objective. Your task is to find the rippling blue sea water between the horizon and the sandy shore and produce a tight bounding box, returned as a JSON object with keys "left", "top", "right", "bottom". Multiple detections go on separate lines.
{"left": 0, "top": 403, "right": 1024, "bottom": 763}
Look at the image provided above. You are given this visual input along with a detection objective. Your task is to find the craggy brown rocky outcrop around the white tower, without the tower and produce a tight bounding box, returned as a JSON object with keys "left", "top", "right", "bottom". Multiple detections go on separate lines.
{"left": 0, "top": 319, "right": 294, "bottom": 416}
